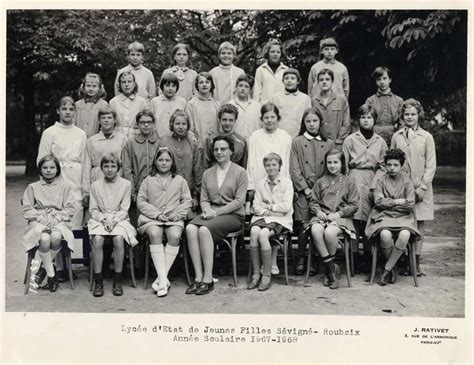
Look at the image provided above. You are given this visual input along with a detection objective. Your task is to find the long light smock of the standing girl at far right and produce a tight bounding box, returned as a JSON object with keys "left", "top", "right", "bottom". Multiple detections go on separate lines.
{"left": 390, "top": 126, "right": 436, "bottom": 221}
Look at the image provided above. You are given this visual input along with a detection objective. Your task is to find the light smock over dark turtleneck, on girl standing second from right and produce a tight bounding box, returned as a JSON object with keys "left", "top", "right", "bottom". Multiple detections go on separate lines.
{"left": 342, "top": 131, "right": 388, "bottom": 221}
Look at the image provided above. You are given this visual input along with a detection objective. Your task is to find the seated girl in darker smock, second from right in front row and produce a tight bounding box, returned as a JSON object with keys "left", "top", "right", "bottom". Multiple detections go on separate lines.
{"left": 309, "top": 149, "right": 359, "bottom": 289}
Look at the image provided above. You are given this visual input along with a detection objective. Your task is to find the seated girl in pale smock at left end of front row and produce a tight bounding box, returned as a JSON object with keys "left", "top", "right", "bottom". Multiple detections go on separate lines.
{"left": 21, "top": 155, "right": 80, "bottom": 292}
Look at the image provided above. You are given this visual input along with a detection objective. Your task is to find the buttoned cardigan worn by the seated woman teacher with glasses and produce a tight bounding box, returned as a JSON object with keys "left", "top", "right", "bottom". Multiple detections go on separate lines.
{"left": 200, "top": 162, "right": 248, "bottom": 217}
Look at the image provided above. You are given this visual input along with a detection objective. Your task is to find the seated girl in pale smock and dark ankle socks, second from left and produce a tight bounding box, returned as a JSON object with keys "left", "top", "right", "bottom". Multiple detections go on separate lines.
{"left": 87, "top": 154, "right": 138, "bottom": 297}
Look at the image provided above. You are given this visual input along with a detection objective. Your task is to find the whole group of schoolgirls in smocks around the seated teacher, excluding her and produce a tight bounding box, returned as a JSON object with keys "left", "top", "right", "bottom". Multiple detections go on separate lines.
{"left": 22, "top": 38, "right": 436, "bottom": 297}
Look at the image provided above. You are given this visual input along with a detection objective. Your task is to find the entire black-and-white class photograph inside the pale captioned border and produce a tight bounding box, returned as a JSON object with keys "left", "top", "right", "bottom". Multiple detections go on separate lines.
{"left": 2, "top": 8, "right": 472, "bottom": 318}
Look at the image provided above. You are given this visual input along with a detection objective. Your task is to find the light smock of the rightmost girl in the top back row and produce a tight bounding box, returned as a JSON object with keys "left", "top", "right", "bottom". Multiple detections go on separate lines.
{"left": 308, "top": 59, "right": 349, "bottom": 98}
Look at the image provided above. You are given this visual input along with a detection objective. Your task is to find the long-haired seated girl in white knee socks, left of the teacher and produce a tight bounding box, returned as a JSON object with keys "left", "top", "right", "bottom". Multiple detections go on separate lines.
{"left": 137, "top": 147, "right": 192, "bottom": 297}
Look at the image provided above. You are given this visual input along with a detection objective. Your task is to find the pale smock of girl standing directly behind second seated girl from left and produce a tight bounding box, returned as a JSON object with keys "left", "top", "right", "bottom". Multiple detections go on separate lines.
{"left": 82, "top": 130, "right": 127, "bottom": 196}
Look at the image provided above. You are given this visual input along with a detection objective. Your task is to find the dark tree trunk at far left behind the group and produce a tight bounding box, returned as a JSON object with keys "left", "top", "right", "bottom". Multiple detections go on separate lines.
{"left": 22, "top": 72, "right": 38, "bottom": 176}
